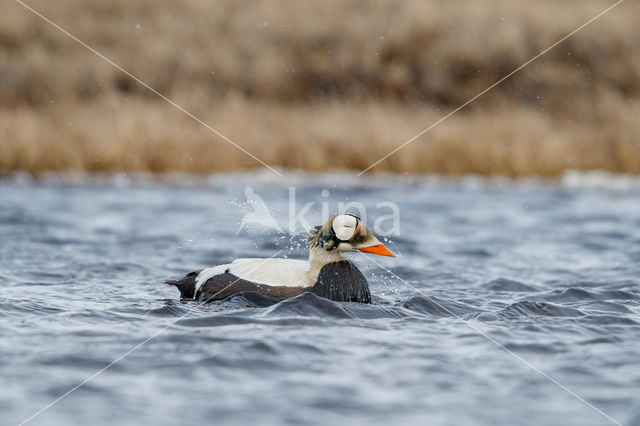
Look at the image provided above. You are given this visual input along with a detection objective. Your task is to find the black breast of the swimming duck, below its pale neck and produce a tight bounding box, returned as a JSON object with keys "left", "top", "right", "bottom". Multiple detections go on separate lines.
{"left": 311, "top": 260, "right": 371, "bottom": 303}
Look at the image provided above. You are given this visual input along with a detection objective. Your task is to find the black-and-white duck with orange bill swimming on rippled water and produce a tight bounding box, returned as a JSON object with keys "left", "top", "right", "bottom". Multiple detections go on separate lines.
{"left": 165, "top": 214, "right": 396, "bottom": 303}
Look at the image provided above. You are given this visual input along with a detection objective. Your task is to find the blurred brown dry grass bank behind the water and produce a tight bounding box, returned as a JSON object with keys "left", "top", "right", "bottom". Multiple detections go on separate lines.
{"left": 0, "top": 0, "right": 640, "bottom": 177}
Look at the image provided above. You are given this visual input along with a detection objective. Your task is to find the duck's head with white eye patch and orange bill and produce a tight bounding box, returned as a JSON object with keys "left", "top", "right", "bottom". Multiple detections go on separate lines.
{"left": 309, "top": 214, "right": 395, "bottom": 257}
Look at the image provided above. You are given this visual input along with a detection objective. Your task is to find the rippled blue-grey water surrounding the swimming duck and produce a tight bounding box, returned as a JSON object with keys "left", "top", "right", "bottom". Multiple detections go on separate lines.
{"left": 0, "top": 173, "right": 640, "bottom": 425}
